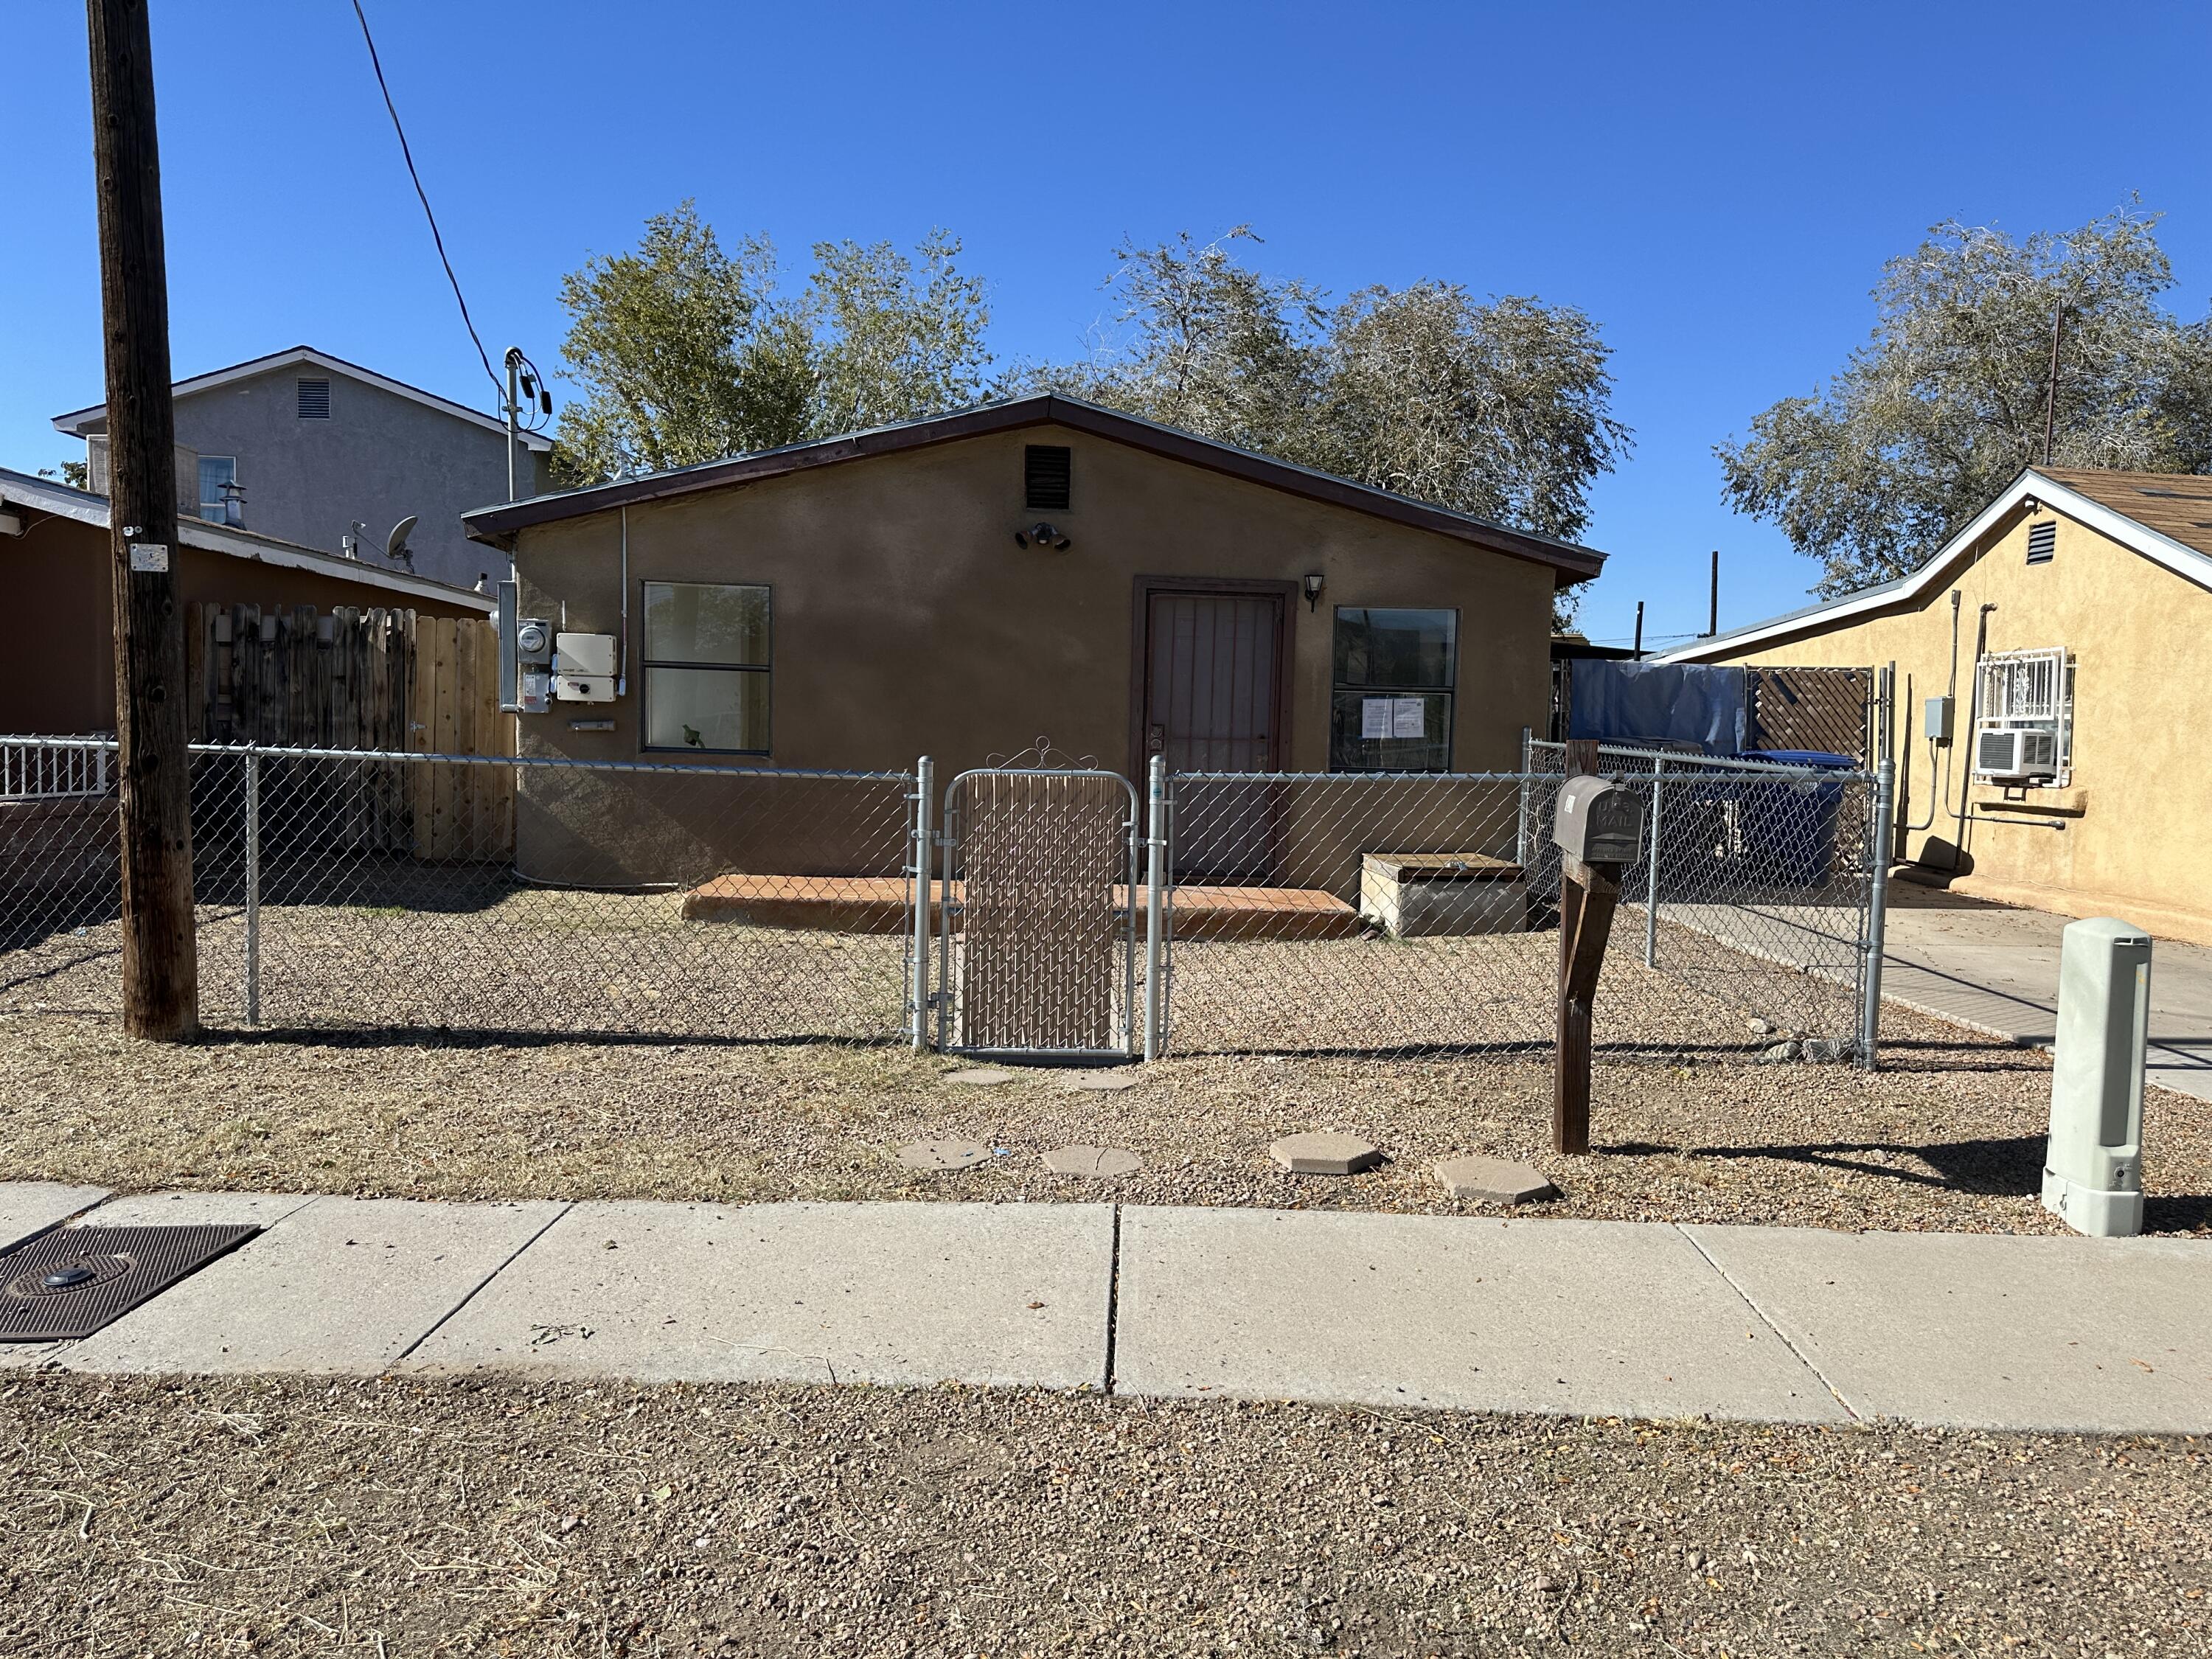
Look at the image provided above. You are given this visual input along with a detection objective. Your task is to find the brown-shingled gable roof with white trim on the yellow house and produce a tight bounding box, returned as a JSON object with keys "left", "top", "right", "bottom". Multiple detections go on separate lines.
{"left": 1657, "top": 467, "right": 2212, "bottom": 661}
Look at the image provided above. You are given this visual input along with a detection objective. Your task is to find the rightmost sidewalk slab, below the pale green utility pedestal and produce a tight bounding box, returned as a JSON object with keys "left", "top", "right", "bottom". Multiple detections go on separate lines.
{"left": 1683, "top": 1225, "right": 2212, "bottom": 1433}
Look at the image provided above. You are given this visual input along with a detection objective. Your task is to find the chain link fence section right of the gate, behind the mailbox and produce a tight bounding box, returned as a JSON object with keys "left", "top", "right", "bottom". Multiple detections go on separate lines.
{"left": 1168, "top": 745, "right": 1871, "bottom": 1057}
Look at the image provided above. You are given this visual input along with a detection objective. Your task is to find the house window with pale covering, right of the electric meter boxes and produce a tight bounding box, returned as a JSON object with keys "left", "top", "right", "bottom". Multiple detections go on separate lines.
{"left": 644, "top": 582, "right": 770, "bottom": 754}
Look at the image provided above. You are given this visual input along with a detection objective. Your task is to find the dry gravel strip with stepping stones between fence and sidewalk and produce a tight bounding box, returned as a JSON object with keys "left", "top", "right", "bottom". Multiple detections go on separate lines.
{"left": 0, "top": 1011, "right": 2212, "bottom": 1232}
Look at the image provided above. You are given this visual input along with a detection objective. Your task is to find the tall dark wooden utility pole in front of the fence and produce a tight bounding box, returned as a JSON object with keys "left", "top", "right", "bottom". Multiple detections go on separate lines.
{"left": 84, "top": 0, "right": 199, "bottom": 1042}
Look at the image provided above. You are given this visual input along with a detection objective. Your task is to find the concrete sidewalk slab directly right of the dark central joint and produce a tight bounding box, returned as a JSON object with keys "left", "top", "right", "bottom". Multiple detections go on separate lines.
{"left": 1115, "top": 1208, "right": 1847, "bottom": 1422}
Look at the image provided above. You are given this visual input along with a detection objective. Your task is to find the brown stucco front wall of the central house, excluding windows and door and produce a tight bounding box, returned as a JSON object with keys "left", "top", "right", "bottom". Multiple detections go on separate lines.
{"left": 515, "top": 427, "right": 1555, "bottom": 883}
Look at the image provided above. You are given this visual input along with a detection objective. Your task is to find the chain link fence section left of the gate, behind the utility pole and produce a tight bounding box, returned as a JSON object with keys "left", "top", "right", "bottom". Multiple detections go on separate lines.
{"left": 0, "top": 741, "right": 916, "bottom": 1042}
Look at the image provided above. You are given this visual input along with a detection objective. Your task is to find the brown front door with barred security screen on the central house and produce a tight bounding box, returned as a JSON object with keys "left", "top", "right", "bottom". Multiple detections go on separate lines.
{"left": 1144, "top": 591, "right": 1287, "bottom": 880}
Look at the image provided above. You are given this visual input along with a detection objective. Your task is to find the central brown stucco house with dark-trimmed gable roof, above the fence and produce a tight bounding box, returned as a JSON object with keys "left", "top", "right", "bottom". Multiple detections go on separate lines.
{"left": 465, "top": 396, "right": 1604, "bottom": 878}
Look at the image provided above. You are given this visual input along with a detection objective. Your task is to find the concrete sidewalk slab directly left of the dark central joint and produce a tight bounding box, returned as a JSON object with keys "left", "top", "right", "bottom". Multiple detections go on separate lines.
{"left": 405, "top": 1201, "right": 1113, "bottom": 1387}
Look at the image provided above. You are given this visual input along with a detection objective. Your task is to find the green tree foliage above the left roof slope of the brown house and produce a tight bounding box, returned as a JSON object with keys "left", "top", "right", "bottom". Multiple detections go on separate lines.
{"left": 557, "top": 201, "right": 991, "bottom": 482}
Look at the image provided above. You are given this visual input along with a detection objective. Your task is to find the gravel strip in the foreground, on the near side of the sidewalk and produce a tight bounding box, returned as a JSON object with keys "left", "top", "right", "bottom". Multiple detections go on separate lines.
{"left": 0, "top": 1376, "right": 2212, "bottom": 1659}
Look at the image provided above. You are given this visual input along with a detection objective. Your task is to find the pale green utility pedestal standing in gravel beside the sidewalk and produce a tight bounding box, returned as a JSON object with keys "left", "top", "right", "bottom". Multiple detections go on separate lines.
{"left": 2044, "top": 916, "right": 2150, "bottom": 1239}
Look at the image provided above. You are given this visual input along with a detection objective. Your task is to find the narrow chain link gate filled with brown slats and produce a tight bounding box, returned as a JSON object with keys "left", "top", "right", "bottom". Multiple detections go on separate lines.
{"left": 936, "top": 768, "right": 1137, "bottom": 1062}
